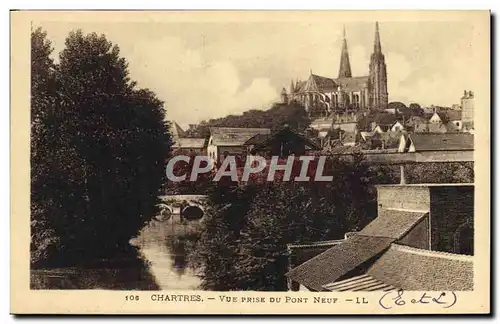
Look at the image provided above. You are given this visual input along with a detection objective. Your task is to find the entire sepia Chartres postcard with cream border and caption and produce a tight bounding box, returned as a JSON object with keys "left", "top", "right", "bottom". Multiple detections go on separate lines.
{"left": 11, "top": 11, "right": 491, "bottom": 315}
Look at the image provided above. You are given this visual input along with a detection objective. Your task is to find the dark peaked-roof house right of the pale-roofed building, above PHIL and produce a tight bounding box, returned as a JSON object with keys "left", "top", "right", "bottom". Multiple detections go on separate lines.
{"left": 244, "top": 126, "right": 321, "bottom": 157}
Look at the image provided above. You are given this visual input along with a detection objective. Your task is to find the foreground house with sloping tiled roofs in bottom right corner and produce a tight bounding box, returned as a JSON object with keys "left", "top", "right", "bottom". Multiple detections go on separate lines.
{"left": 286, "top": 184, "right": 474, "bottom": 292}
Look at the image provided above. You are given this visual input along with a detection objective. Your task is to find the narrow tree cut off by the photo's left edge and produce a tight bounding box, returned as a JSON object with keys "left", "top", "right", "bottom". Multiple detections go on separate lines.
{"left": 30, "top": 28, "right": 62, "bottom": 263}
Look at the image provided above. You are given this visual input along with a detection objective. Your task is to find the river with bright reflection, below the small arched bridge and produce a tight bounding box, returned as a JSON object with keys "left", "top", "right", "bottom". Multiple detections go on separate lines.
{"left": 31, "top": 214, "right": 201, "bottom": 290}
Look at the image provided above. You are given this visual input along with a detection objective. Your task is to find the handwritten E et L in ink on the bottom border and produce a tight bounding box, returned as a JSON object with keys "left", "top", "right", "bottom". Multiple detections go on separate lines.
{"left": 379, "top": 289, "right": 457, "bottom": 309}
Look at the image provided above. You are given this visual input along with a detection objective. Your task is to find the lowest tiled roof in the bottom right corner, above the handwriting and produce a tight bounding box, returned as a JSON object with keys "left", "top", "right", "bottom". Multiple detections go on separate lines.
{"left": 366, "top": 244, "right": 474, "bottom": 291}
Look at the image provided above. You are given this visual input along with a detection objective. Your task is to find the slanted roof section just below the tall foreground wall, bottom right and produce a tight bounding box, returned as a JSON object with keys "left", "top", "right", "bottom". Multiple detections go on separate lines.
{"left": 359, "top": 209, "right": 427, "bottom": 239}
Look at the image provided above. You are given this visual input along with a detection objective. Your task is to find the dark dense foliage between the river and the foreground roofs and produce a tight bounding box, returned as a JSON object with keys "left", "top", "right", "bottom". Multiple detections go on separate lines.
{"left": 191, "top": 155, "right": 394, "bottom": 290}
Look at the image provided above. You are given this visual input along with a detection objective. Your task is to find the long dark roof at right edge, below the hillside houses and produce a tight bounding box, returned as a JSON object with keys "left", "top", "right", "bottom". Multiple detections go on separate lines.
{"left": 409, "top": 133, "right": 474, "bottom": 152}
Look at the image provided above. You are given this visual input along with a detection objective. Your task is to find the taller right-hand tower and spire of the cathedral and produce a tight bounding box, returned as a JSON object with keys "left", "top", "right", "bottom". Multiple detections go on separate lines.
{"left": 369, "top": 22, "right": 389, "bottom": 110}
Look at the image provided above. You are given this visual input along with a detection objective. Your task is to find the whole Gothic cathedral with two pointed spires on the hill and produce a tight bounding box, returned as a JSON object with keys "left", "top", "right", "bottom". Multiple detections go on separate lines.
{"left": 281, "top": 22, "right": 388, "bottom": 117}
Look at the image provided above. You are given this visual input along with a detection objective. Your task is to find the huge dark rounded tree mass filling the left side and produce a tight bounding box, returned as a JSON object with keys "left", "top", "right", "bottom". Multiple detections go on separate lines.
{"left": 32, "top": 30, "right": 171, "bottom": 266}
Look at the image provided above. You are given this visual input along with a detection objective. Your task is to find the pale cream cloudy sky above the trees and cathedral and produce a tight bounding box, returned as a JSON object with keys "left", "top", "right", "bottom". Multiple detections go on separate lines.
{"left": 33, "top": 14, "right": 489, "bottom": 127}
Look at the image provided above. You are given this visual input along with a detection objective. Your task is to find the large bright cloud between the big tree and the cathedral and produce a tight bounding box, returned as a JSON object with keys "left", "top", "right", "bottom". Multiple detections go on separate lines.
{"left": 116, "top": 37, "right": 279, "bottom": 126}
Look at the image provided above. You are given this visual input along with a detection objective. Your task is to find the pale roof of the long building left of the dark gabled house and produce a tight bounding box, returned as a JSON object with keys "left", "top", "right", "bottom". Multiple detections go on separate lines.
{"left": 210, "top": 127, "right": 271, "bottom": 146}
